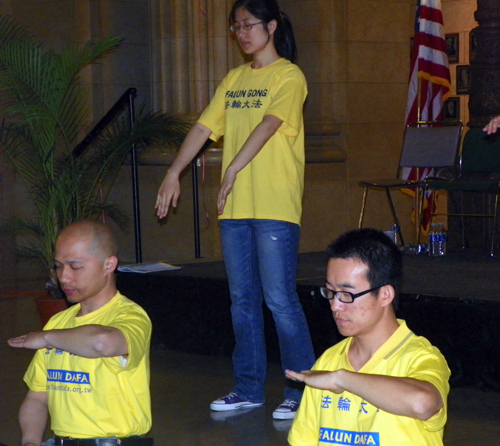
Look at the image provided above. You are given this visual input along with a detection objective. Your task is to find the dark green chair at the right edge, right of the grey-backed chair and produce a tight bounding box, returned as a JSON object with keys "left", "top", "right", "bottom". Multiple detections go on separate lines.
{"left": 425, "top": 128, "right": 500, "bottom": 256}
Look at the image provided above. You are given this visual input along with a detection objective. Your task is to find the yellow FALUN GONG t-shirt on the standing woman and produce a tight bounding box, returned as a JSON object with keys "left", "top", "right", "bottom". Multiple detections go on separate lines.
{"left": 198, "top": 58, "right": 307, "bottom": 224}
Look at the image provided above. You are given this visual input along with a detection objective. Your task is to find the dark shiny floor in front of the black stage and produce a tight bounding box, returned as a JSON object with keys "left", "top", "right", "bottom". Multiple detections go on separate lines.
{"left": 0, "top": 297, "right": 500, "bottom": 446}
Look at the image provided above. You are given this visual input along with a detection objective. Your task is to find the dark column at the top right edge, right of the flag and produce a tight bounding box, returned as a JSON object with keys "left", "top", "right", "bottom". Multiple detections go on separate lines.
{"left": 469, "top": 0, "right": 500, "bottom": 127}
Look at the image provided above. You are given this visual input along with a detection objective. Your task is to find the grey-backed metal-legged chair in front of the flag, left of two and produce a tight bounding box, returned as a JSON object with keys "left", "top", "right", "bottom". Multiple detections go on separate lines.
{"left": 358, "top": 121, "right": 463, "bottom": 245}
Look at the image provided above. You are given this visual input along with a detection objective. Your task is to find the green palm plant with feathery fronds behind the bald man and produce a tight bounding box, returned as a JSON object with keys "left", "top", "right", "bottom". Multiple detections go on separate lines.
{"left": 0, "top": 16, "right": 188, "bottom": 324}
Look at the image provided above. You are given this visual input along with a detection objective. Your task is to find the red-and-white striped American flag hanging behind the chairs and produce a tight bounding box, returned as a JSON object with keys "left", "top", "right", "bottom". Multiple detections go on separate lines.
{"left": 403, "top": 0, "right": 451, "bottom": 232}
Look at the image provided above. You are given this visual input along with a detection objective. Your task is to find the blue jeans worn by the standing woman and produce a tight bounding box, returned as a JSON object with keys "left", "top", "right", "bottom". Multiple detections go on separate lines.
{"left": 220, "top": 219, "right": 315, "bottom": 402}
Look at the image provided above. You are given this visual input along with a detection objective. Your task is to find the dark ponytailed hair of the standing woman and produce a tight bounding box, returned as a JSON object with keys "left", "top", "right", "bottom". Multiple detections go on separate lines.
{"left": 229, "top": 0, "right": 297, "bottom": 62}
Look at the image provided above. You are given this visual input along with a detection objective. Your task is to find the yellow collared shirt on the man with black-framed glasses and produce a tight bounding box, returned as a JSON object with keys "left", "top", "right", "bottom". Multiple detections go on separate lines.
{"left": 288, "top": 320, "right": 450, "bottom": 446}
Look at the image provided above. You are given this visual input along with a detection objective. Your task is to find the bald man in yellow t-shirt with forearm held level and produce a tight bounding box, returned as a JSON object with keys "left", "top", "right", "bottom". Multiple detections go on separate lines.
{"left": 8, "top": 220, "right": 152, "bottom": 446}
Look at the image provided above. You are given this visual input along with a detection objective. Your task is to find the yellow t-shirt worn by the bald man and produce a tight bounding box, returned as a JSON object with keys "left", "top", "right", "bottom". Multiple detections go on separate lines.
{"left": 24, "top": 293, "right": 151, "bottom": 438}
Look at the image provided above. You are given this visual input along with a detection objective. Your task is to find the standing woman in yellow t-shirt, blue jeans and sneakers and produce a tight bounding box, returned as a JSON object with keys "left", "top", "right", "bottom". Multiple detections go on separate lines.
{"left": 156, "top": 0, "right": 315, "bottom": 419}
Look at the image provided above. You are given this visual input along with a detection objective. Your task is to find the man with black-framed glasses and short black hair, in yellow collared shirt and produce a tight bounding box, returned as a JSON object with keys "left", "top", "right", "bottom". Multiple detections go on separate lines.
{"left": 286, "top": 228, "right": 450, "bottom": 446}
